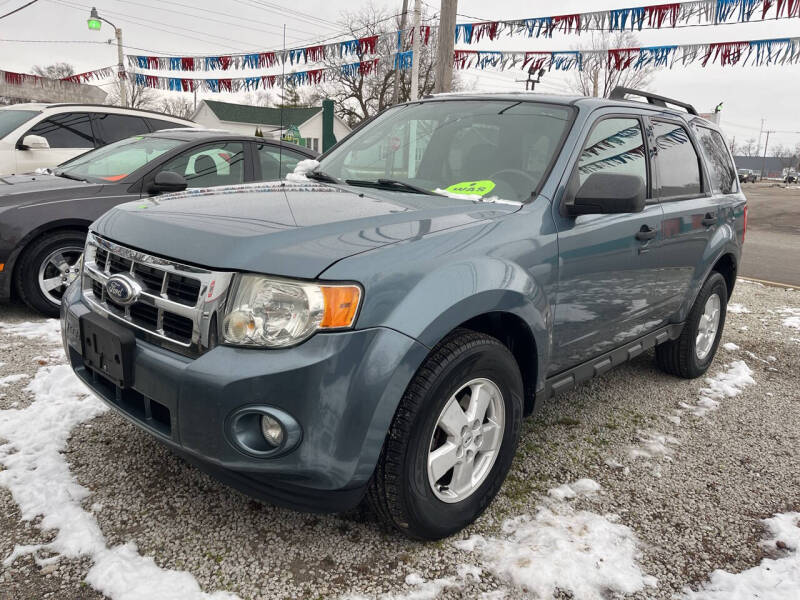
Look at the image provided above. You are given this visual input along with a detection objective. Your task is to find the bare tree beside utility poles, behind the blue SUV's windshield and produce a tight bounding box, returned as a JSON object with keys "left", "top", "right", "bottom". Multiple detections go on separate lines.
{"left": 306, "top": 4, "right": 458, "bottom": 126}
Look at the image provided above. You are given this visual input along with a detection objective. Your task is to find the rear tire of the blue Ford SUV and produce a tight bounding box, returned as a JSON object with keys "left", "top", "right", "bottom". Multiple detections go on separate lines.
{"left": 656, "top": 271, "right": 728, "bottom": 379}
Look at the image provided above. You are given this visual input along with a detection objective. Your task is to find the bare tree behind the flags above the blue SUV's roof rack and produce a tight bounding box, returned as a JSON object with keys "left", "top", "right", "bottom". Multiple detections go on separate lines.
{"left": 568, "top": 31, "right": 655, "bottom": 98}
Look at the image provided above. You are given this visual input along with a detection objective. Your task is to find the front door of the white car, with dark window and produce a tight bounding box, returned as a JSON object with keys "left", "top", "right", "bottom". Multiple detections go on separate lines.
{"left": 14, "top": 112, "right": 95, "bottom": 173}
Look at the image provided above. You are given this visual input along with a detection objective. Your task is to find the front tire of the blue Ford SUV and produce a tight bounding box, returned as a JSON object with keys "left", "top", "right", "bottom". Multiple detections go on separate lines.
{"left": 367, "top": 329, "right": 523, "bottom": 540}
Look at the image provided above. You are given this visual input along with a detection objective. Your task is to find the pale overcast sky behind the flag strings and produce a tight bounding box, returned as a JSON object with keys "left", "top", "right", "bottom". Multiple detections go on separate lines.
{"left": 0, "top": 0, "right": 800, "bottom": 146}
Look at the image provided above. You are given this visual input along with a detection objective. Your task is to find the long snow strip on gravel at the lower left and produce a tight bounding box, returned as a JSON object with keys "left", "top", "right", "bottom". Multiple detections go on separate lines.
{"left": 0, "top": 321, "right": 236, "bottom": 600}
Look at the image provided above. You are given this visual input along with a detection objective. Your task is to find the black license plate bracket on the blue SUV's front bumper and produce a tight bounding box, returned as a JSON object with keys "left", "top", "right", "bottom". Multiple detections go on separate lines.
{"left": 79, "top": 313, "right": 136, "bottom": 389}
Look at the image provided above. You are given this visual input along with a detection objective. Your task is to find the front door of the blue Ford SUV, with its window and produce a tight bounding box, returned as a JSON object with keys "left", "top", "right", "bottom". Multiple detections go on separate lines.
{"left": 548, "top": 115, "right": 665, "bottom": 375}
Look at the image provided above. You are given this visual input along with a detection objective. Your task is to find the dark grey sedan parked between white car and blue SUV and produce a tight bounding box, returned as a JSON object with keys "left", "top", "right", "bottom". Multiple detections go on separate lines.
{"left": 0, "top": 128, "right": 317, "bottom": 316}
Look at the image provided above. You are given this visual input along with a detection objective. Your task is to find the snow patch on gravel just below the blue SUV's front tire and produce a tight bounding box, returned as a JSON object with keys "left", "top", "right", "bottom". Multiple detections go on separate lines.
{"left": 454, "top": 508, "right": 656, "bottom": 600}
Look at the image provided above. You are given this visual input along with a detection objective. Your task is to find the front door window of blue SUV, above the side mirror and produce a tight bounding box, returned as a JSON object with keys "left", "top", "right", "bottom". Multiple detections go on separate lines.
{"left": 578, "top": 117, "right": 647, "bottom": 186}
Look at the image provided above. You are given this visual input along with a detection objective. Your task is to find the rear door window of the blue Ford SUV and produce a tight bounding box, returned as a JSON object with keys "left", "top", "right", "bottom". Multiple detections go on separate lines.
{"left": 653, "top": 121, "right": 702, "bottom": 198}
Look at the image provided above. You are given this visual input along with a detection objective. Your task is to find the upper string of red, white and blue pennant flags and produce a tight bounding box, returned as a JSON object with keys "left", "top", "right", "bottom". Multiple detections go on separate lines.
{"left": 128, "top": 0, "right": 800, "bottom": 71}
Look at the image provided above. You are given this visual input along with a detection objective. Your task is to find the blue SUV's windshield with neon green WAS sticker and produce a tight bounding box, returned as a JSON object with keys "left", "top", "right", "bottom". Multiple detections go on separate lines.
{"left": 317, "top": 100, "right": 572, "bottom": 202}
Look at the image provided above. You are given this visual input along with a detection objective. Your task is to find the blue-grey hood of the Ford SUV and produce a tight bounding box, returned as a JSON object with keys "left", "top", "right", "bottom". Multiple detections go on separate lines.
{"left": 92, "top": 182, "right": 520, "bottom": 279}
